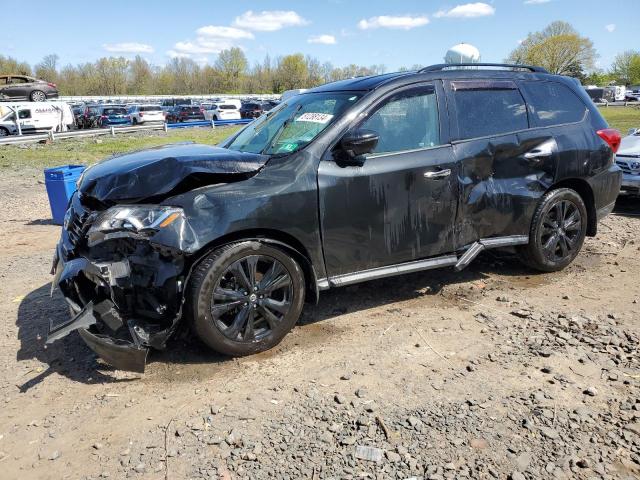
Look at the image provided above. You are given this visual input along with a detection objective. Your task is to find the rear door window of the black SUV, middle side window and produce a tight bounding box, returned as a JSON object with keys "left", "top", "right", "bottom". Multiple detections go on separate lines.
{"left": 451, "top": 80, "right": 529, "bottom": 140}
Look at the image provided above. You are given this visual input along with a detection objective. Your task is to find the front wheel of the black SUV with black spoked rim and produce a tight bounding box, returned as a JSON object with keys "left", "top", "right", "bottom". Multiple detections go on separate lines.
{"left": 186, "top": 241, "right": 305, "bottom": 356}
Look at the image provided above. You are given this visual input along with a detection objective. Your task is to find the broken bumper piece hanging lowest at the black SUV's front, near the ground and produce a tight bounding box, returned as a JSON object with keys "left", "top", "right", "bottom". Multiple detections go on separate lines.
{"left": 47, "top": 300, "right": 149, "bottom": 373}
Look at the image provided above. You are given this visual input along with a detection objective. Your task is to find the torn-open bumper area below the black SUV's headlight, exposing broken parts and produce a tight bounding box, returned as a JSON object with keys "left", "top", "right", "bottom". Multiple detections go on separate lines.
{"left": 47, "top": 231, "right": 188, "bottom": 373}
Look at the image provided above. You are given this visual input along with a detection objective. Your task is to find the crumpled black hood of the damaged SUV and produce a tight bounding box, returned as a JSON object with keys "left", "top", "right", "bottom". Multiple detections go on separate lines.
{"left": 79, "top": 143, "right": 269, "bottom": 203}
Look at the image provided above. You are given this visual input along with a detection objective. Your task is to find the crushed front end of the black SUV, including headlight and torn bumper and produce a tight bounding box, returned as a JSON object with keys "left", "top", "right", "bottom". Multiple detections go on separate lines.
{"left": 47, "top": 192, "right": 189, "bottom": 372}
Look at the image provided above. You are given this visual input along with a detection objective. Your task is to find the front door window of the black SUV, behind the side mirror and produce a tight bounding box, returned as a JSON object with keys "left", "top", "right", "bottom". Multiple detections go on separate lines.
{"left": 360, "top": 87, "right": 440, "bottom": 153}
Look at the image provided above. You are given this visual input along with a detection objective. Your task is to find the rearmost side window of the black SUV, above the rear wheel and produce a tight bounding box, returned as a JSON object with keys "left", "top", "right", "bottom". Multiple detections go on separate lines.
{"left": 522, "top": 82, "right": 587, "bottom": 127}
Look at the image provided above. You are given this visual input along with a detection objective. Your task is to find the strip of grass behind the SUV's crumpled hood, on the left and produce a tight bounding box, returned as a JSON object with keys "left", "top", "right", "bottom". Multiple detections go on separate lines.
{"left": 0, "top": 127, "right": 239, "bottom": 170}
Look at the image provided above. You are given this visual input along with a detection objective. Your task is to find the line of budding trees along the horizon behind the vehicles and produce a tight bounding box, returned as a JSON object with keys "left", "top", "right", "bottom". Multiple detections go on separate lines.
{"left": 0, "top": 22, "right": 640, "bottom": 95}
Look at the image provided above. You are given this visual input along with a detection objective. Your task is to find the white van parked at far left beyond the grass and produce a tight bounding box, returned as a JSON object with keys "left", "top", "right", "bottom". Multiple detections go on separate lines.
{"left": 0, "top": 102, "right": 74, "bottom": 136}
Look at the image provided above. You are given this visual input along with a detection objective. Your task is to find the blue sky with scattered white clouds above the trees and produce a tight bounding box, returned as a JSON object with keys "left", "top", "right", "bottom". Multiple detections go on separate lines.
{"left": 0, "top": 0, "right": 640, "bottom": 71}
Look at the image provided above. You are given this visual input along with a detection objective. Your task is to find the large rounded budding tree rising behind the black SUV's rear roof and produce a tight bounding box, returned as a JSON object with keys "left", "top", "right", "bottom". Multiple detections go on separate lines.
{"left": 506, "top": 22, "right": 598, "bottom": 77}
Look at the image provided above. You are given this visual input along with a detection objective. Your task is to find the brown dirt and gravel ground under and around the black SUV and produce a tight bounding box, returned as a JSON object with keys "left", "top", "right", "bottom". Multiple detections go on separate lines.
{"left": 0, "top": 170, "right": 640, "bottom": 480}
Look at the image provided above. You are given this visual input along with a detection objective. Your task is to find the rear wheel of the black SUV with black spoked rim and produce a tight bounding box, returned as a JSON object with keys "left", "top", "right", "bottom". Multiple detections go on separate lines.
{"left": 518, "top": 188, "right": 587, "bottom": 272}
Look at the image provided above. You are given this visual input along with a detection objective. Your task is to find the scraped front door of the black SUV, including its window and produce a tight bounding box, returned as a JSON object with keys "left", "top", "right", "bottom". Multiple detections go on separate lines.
{"left": 318, "top": 83, "right": 458, "bottom": 278}
